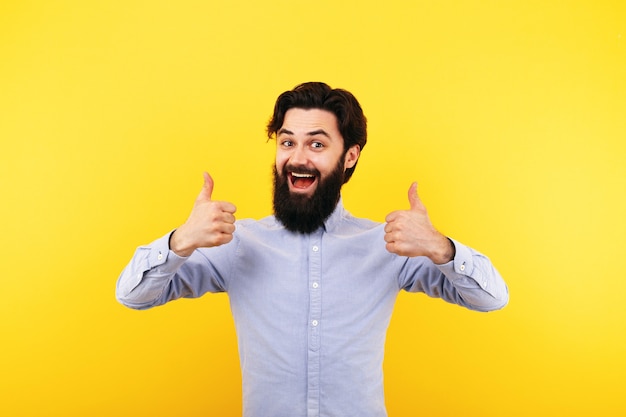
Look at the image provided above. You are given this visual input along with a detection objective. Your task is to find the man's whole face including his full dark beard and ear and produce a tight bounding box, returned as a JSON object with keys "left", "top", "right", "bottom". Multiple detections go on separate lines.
{"left": 274, "top": 108, "right": 359, "bottom": 233}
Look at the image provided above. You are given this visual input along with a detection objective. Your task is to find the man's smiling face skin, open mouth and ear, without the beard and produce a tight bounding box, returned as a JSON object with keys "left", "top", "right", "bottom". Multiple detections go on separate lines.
{"left": 276, "top": 108, "right": 360, "bottom": 197}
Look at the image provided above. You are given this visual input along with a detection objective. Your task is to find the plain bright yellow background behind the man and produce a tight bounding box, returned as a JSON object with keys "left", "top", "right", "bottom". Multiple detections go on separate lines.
{"left": 0, "top": 0, "right": 626, "bottom": 417}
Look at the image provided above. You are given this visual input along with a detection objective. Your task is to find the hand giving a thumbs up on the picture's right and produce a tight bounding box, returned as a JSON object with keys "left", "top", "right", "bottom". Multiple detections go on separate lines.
{"left": 385, "top": 182, "right": 455, "bottom": 264}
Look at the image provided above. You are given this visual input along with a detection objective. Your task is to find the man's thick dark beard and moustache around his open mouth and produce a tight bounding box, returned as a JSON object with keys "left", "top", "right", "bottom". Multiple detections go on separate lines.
{"left": 274, "top": 158, "right": 344, "bottom": 234}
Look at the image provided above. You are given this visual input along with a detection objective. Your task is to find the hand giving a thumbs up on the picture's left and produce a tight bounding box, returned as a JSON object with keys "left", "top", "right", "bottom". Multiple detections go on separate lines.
{"left": 170, "top": 172, "right": 237, "bottom": 256}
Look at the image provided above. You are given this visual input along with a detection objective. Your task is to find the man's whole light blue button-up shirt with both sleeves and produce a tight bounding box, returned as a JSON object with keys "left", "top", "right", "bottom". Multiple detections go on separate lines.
{"left": 117, "top": 202, "right": 508, "bottom": 417}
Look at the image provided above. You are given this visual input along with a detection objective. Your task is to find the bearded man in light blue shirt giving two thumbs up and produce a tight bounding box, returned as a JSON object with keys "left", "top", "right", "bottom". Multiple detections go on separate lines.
{"left": 117, "top": 83, "right": 508, "bottom": 417}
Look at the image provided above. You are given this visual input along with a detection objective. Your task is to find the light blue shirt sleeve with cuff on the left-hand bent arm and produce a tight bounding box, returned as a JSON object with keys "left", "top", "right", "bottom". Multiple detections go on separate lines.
{"left": 116, "top": 232, "right": 225, "bottom": 310}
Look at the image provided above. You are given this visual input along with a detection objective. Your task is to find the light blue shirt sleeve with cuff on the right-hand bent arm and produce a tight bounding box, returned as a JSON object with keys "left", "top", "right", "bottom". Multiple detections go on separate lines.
{"left": 401, "top": 239, "right": 509, "bottom": 311}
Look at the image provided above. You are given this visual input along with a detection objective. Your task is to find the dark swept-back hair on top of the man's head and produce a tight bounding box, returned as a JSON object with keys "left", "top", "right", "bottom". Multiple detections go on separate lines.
{"left": 267, "top": 82, "right": 367, "bottom": 183}
